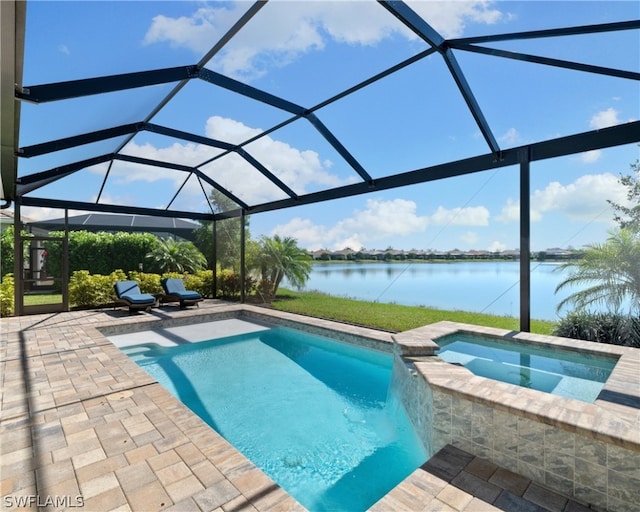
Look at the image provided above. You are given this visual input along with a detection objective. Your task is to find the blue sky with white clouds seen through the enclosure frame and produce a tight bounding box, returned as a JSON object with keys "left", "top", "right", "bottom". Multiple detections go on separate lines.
{"left": 19, "top": 0, "right": 640, "bottom": 250}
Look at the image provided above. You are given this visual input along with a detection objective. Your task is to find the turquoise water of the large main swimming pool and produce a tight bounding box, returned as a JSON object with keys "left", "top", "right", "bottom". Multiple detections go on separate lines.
{"left": 122, "top": 327, "right": 427, "bottom": 512}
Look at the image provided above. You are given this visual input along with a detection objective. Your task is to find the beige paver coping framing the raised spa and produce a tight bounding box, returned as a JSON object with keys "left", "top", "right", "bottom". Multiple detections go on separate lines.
{"left": 392, "top": 321, "right": 640, "bottom": 451}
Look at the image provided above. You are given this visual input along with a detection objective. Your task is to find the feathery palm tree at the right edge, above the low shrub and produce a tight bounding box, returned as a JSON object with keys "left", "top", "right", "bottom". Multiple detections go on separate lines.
{"left": 556, "top": 228, "right": 640, "bottom": 312}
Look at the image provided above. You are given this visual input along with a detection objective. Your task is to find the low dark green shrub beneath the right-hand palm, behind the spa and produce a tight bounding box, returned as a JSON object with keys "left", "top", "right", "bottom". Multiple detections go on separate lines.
{"left": 553, "top": 312, "right": 640, "bottom": 347}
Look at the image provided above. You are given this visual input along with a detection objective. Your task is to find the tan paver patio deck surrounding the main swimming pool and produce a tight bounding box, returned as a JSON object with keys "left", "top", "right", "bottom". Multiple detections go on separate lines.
{"left": 0, "top": 300, "right": 636, "bottom": 512}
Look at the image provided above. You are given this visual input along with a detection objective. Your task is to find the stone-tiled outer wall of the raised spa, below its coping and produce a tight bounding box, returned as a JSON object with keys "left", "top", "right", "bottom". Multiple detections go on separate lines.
{"left": 394, "top": 355, "right": 640, "bottom": 512}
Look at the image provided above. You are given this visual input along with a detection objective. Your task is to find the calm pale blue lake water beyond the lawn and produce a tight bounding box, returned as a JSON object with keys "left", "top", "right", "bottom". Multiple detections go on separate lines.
{"left": 290, "top": 261, "right": 570, "bottom": 320}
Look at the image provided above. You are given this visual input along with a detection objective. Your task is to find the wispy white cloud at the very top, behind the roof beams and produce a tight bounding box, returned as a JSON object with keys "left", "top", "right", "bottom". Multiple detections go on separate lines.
{"left": 144, "top": 0, "right": 502, "bottom": 79}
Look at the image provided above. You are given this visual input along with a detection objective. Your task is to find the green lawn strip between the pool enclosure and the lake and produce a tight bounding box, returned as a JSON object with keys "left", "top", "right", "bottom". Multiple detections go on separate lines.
{"left": 272, "top": 289, "right": 555, "bottom": 334}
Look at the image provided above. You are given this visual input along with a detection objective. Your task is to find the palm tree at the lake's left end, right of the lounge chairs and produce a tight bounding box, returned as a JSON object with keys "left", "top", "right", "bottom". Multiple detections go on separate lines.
{"left": 257, "top": 235, "right": 311, "bottom": 301}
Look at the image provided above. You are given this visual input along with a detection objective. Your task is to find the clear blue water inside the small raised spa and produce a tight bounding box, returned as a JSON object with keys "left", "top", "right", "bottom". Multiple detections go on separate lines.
{"left": 436, "top": 333, "right": 617, "bottom": 402}
